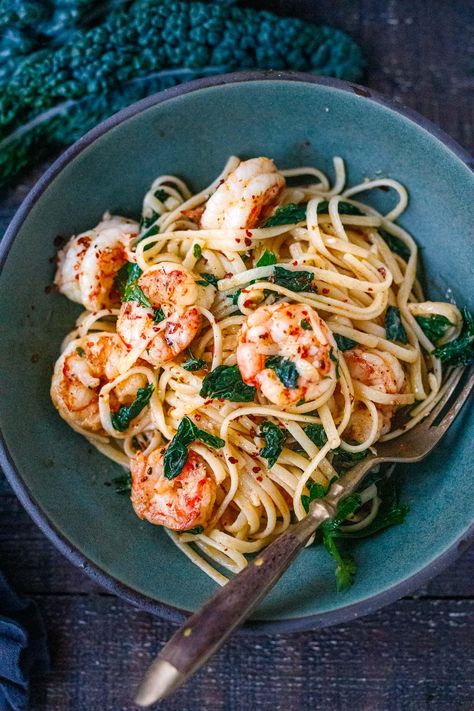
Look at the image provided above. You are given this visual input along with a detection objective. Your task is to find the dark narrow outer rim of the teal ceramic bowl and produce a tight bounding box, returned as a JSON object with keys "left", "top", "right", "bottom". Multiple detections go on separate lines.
{"left": 0, "top": 70, "right": 474, "bottom": 634}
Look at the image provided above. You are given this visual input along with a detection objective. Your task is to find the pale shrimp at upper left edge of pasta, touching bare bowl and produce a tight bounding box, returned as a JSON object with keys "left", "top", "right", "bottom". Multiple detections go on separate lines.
{"left": 54, "top": 214, "right": 138, "bottom": 311}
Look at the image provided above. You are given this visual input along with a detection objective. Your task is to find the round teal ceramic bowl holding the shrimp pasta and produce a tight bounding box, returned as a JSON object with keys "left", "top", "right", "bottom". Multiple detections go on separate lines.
{"left": 0, "top": 73, "right": 474, "bottom": 632}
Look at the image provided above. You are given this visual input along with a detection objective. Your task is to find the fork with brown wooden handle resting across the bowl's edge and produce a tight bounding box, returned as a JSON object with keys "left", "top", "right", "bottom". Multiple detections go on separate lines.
{"left": 135, "top": 368, "right": 474, "bottom": 706}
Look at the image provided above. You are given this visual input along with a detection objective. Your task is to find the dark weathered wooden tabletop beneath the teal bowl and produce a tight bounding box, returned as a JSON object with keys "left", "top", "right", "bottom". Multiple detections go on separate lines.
{"left": 0, "top": 0, "right": 474, "bottom": 711}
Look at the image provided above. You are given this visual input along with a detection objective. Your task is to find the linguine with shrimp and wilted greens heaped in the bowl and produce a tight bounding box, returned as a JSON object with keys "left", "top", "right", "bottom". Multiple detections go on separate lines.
{"left": 51, "top": 156, "right": 466, "bottom": 587}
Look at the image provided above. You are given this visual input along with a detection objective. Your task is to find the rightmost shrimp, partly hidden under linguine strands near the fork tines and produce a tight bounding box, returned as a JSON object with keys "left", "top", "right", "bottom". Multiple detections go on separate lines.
{"left": 344, "top": 348, "right": 405, "bottom": 442}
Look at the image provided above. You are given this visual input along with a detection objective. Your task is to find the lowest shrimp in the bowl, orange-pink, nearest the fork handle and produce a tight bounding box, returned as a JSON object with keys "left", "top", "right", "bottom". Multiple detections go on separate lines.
{"left": 130, "top": 447, "right": 217, "bottom": 531}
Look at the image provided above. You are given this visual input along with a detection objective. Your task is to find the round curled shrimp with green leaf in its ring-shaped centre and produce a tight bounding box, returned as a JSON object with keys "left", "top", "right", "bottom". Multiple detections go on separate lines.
{"left": 237, "top": 302, "right": 337, "bottom": 406}
